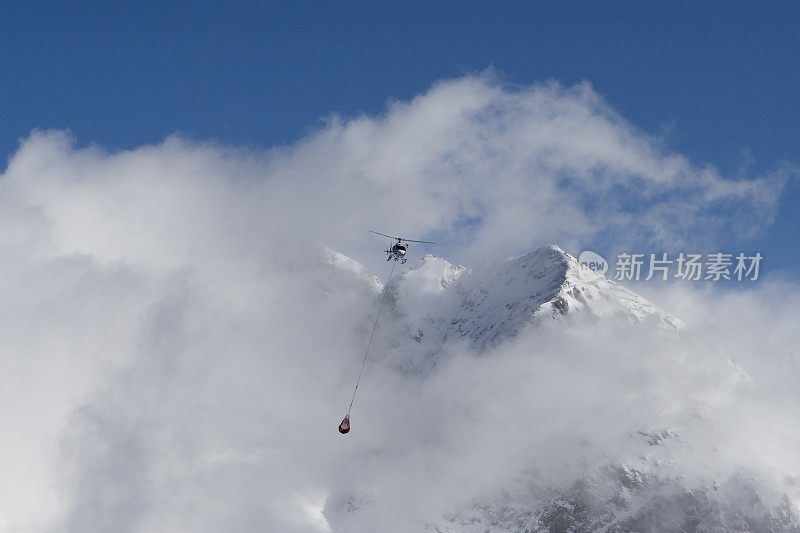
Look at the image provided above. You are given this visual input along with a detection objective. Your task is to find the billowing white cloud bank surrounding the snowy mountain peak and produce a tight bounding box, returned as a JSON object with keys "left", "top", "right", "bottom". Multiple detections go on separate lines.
{"left": 0, "top": 77, "right": 800, "bottom": 532}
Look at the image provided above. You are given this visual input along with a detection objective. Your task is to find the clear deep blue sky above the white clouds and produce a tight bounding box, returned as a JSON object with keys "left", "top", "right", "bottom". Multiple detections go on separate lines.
{"left": 0, "top": 2, "right": 800, "bottom": 278}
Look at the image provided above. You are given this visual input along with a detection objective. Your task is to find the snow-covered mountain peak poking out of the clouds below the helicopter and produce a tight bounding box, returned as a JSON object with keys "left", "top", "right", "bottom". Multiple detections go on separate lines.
{"left": 381, "top": 246, "right": 681, "bottom": 370}
